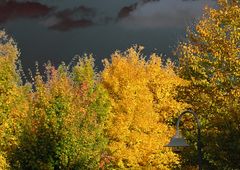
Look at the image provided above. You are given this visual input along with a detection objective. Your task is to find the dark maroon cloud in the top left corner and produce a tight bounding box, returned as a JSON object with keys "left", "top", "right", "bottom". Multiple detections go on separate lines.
{"left": 0, "top": 1, "right": 53, "bottom": 23}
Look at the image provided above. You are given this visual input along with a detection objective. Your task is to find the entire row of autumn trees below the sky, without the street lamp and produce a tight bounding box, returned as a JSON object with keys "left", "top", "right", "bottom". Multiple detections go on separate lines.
{"left": 0, "top": 0, "right": 240, "bottom": 170}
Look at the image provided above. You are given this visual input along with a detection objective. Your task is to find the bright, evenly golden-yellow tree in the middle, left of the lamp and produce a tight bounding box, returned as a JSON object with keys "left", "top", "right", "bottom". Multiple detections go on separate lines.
{"left": 102, "top": 47, "right": 188, "bottom": 169}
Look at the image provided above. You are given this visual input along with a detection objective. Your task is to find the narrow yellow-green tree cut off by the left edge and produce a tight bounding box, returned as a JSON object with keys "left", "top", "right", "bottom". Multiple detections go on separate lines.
{"left": 0, "top": 31, "right": 28, "bottom": 161}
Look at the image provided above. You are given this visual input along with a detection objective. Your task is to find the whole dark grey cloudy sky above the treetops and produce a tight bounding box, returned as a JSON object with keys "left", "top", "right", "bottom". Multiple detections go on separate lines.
{"left": 0, "top": 0, "right": 216, "bottom": 70}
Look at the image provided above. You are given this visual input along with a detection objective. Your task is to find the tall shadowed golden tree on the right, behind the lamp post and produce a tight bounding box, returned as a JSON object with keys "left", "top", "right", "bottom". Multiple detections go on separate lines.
{"left": 178, "top": 0, "right": 240, "bottom": 169}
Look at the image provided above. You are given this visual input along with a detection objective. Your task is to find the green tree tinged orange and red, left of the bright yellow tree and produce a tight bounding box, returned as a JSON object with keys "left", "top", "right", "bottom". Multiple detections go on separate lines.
{"left": 13, "top": 57, "right": 110, "bottom": 170}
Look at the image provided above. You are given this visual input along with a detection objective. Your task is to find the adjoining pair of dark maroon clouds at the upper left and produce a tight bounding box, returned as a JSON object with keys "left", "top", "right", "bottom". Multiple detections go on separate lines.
{"left": 0, "top": 0, "right": 96, "bottom": 31}
